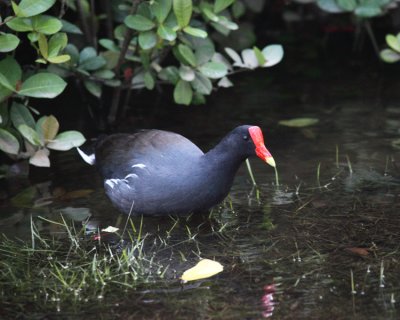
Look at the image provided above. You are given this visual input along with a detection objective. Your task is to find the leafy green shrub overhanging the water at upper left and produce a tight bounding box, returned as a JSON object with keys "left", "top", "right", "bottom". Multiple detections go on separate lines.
{"left": 0, "top": 0, "right": 283, "bottom": 166}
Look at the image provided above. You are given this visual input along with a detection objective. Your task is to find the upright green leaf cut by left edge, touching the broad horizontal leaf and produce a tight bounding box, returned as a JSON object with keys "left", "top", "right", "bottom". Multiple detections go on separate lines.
{"left": 0, "top": 56, "right": 22, "bottom": 95}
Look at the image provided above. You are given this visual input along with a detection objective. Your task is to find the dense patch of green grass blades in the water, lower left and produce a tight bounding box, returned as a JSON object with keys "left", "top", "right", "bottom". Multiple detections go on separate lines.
{"left": 0, "top": 217, "right": 168, "bottom": 318}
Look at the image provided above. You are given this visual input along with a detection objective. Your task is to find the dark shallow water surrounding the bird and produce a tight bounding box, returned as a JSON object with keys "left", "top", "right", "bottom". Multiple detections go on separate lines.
{"left": 0, "top": 55, "right": 400, "bottom": 319}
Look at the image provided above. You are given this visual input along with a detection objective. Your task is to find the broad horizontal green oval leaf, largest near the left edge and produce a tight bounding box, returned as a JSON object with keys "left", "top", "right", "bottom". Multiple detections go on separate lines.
{"left": 18, "top": 73, "right": 67, "bottom": 98}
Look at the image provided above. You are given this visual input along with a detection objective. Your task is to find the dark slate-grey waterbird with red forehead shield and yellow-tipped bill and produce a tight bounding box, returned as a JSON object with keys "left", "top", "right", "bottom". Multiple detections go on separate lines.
{"left": 78, "top": 125, "right": 275, "bottom": 215}
